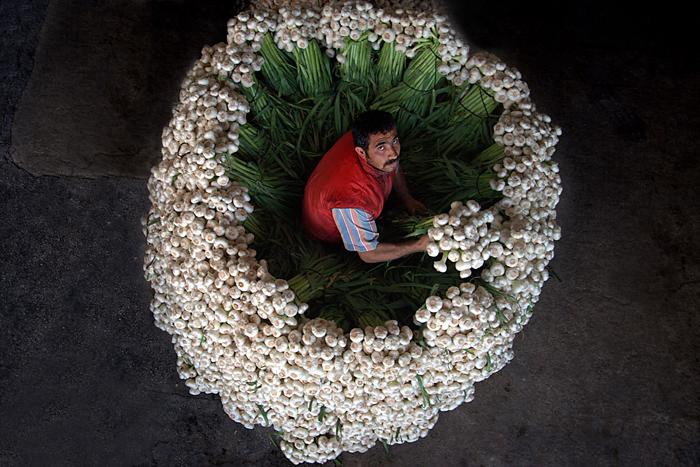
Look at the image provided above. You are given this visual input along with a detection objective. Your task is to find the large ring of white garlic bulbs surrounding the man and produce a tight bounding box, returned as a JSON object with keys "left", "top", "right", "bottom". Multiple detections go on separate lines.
{"left": 143, "top": 3, "right": 561, "bottom": 463}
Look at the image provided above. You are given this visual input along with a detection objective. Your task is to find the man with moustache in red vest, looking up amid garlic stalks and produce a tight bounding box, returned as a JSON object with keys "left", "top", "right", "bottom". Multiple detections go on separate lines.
{"left": 302, "top": 110, "right": 430, "bottom": 263}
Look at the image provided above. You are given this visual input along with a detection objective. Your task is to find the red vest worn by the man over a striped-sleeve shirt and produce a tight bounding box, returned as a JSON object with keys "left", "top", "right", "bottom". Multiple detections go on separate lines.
{"left": 302, "top": 131, "right": 398, "bottom": 243}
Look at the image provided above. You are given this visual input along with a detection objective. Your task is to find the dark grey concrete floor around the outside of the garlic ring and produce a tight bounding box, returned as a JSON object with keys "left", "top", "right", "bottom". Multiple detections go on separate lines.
{"left": 0, "top": 0, "right": 700, "bottom": 466}
